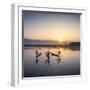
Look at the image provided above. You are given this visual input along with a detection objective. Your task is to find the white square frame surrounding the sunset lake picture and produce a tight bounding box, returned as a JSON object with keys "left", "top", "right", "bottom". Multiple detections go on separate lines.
{"left": 11, "top": 4, "right": 87, "bottom": 86}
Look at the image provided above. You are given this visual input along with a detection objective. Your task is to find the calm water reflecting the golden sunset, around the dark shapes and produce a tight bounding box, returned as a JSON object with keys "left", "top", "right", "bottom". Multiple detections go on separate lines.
{"left": 23, "top": 47, "right": 80, "bottom": 77}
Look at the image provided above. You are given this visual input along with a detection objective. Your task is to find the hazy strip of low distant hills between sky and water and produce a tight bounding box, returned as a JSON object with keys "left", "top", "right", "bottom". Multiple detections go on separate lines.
{"left": 24, "top": 39, "right": 80, "bottom": 46}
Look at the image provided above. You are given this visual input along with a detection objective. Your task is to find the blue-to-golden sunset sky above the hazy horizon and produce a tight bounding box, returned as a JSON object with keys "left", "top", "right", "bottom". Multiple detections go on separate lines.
{"left": 22, "top": 10, "right": 80, "bottom": 42}
